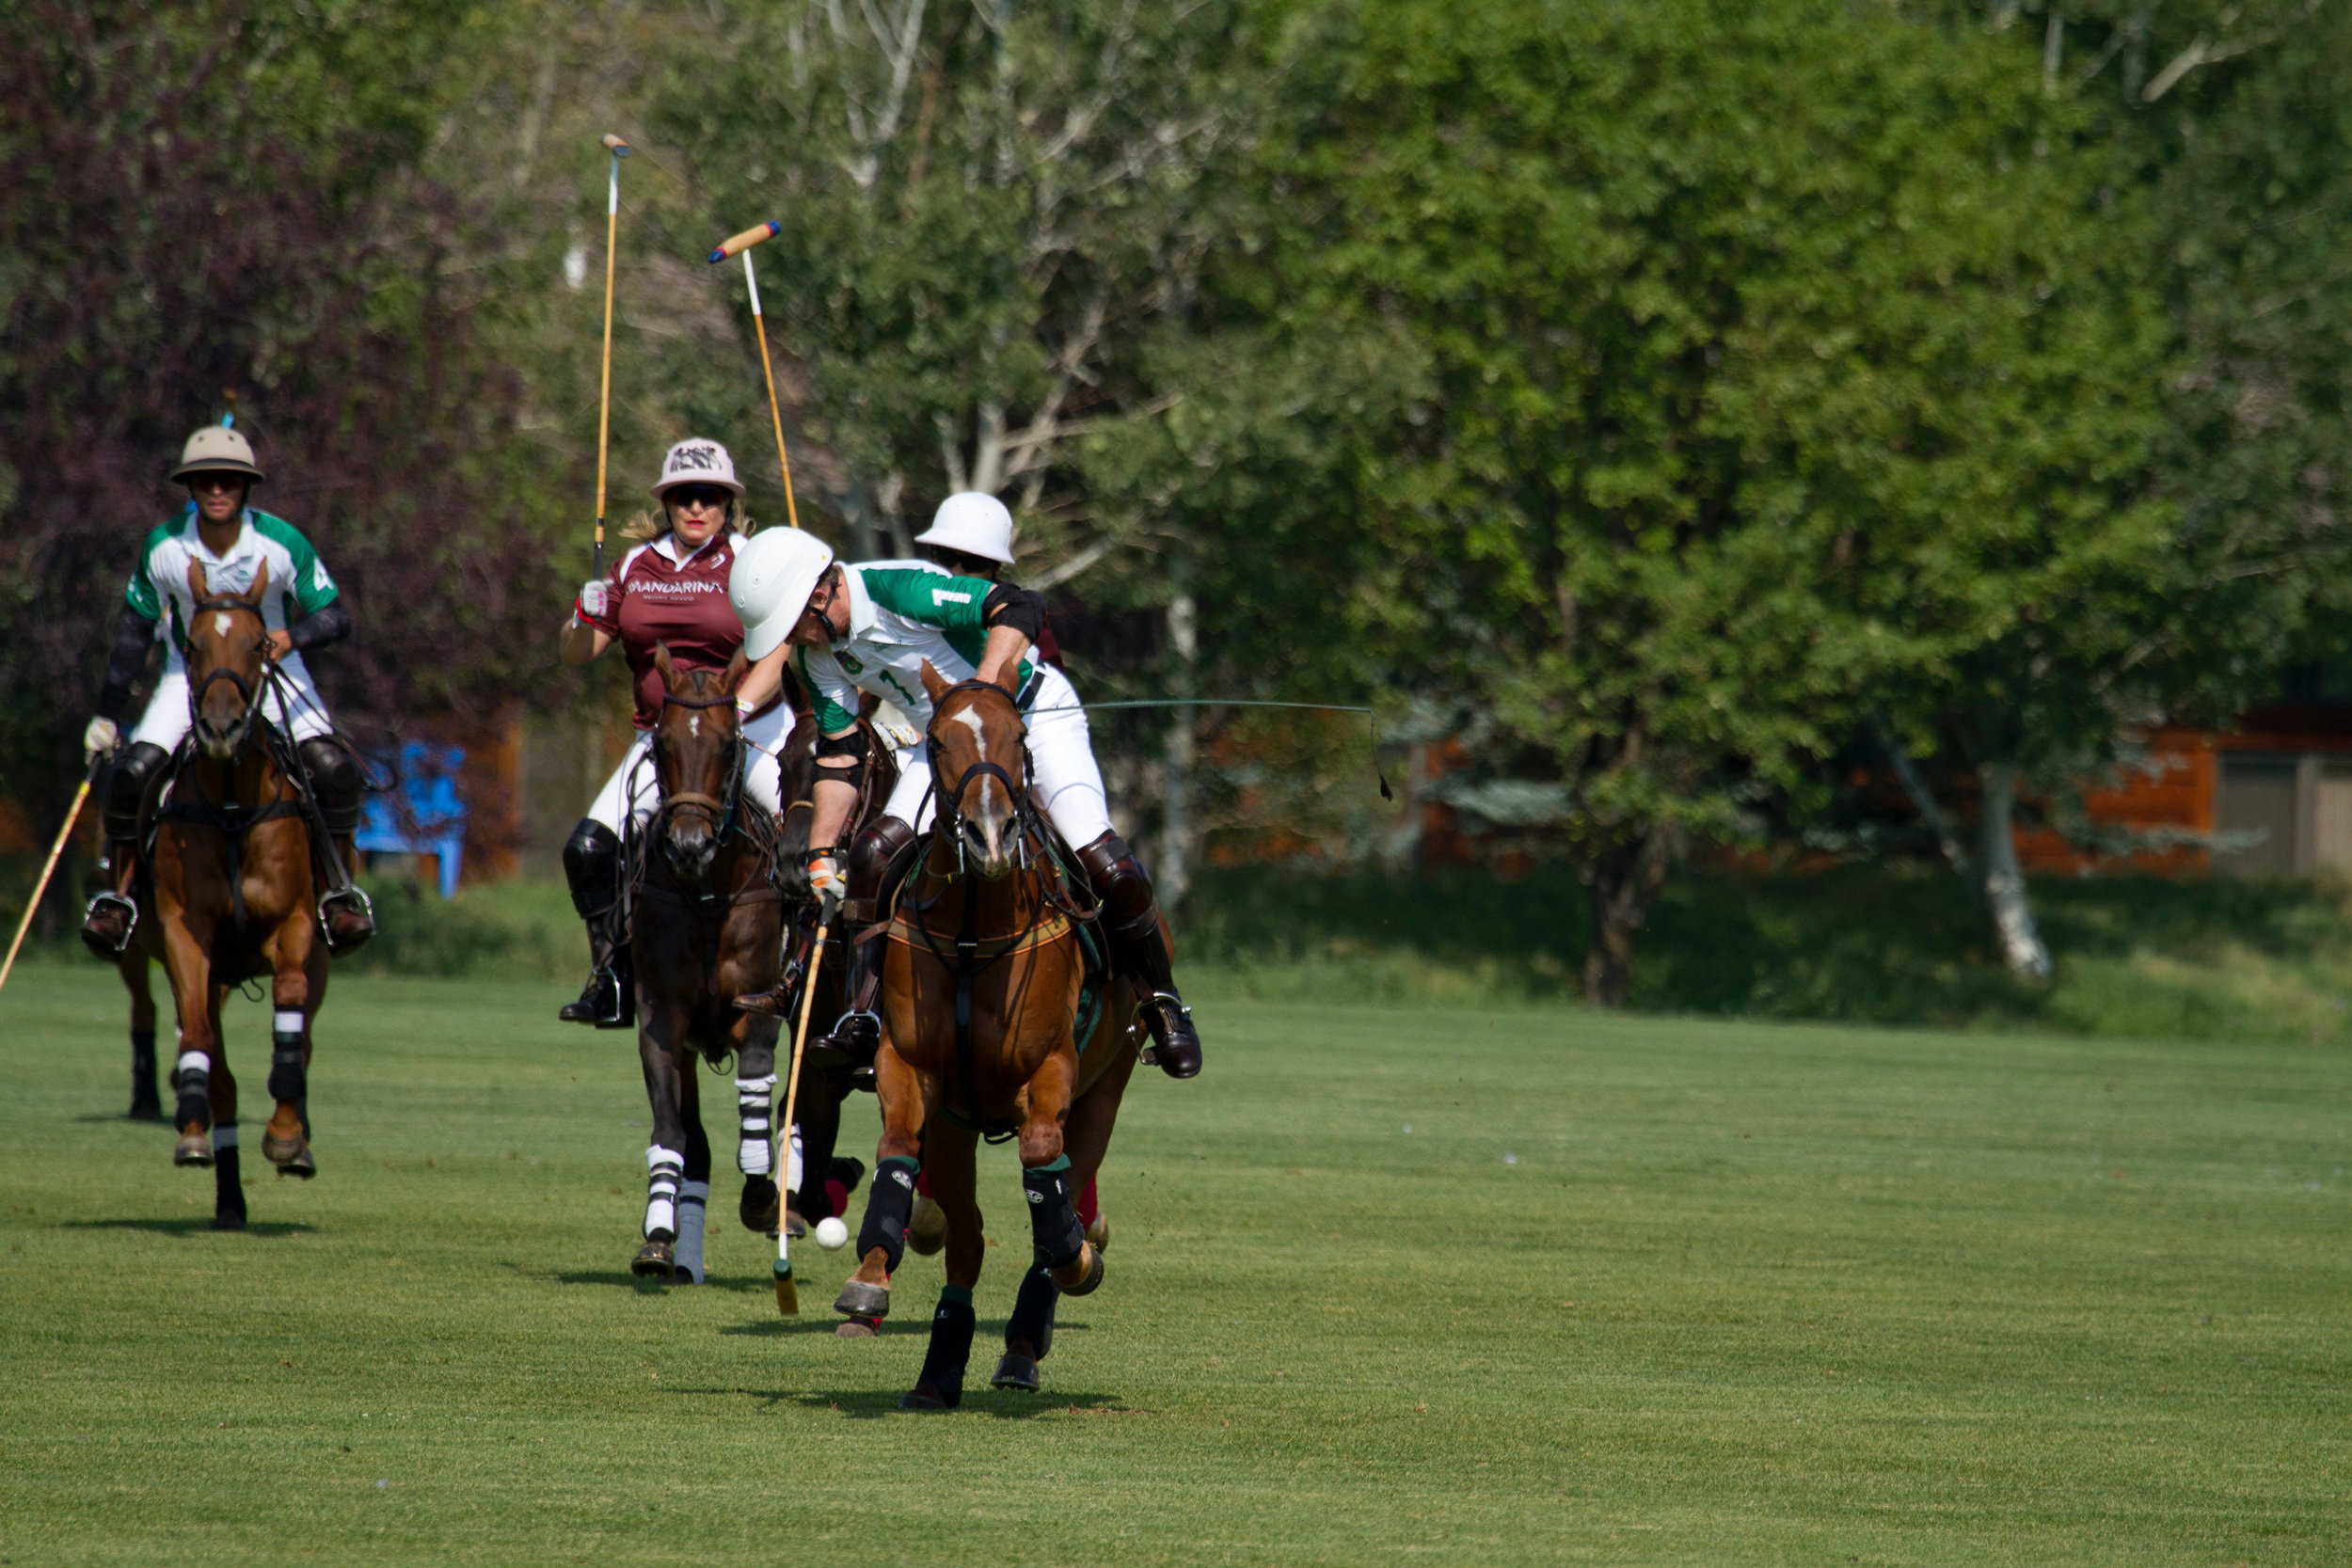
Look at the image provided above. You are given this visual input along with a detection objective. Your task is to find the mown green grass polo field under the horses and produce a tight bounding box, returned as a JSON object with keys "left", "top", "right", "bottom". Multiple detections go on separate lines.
{"left": 0, "top": 966, "right": 2352, "bottom": 1568}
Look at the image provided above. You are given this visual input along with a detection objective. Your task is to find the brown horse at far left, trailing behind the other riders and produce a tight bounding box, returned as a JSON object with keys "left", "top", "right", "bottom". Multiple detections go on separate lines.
{"left": 151, "top": 562, "right": 334, "bottom": 1229}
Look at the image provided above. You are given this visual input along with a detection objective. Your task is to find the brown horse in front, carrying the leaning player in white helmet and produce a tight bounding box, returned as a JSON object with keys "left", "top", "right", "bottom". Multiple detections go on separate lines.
{"left": 835, "top": 665, "right": 1141, "bottom": 1411}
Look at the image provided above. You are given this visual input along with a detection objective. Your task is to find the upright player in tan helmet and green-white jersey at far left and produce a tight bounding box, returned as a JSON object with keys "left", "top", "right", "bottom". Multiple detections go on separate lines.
{"left": 83, "top": 425, "right": 376, "bottom": 959}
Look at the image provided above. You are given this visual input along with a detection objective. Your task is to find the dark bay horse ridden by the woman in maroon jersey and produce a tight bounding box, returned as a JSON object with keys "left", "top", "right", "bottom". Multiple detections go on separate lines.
{"left": 630, "top": 644, "right": 784, "bottom": 1284}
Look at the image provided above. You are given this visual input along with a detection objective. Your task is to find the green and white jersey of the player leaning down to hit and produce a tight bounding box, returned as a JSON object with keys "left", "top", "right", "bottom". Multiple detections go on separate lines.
{"left": 793, "top": 562, "right": 1035, "bottom": 736}
